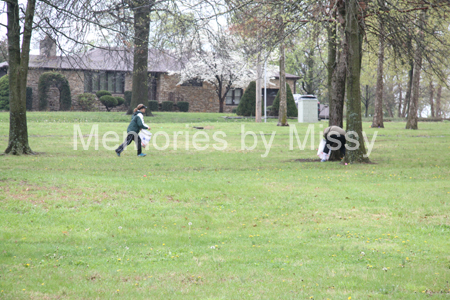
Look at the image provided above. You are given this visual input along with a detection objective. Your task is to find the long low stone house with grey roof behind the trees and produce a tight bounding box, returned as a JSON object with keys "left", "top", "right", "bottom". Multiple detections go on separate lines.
{"left": 0, "top": 38, "right": 300, "bottom": 112}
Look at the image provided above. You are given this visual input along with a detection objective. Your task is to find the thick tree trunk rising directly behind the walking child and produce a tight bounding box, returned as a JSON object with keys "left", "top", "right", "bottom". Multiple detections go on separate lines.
{"left": 127, "top": 0, "right": 154, "bottom": 114}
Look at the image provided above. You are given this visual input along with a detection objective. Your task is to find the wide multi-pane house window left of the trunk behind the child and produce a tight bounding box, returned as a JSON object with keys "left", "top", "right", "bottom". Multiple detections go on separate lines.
{"left": 84, "top": 72, "right": 125, "bottom": 94}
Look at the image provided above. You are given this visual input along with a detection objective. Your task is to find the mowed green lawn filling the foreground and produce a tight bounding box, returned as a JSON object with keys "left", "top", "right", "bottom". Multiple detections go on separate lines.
{"left": 0, "top": 112, "right": 450, "bottom": 299}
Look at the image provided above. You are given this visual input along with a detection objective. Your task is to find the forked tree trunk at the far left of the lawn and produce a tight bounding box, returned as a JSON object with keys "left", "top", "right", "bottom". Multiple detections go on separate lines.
{"left": 5, "top": 0, "right": 36, "bottom": 155}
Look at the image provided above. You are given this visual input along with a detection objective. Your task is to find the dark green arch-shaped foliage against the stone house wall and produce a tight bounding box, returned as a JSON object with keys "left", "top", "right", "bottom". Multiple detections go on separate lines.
{"left": 38, "top": 72, "right": 72, "bottom": 110}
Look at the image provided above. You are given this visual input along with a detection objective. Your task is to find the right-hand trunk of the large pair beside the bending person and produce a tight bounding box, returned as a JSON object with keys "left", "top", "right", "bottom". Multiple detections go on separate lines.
{"left": 345, "top": 0, "right": 369, "bottom": 163}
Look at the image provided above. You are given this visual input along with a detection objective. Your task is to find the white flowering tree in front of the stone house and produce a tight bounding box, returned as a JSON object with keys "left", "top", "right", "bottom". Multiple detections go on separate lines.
{"left": 169, "top": 35, "right": 255, "bottom": 112}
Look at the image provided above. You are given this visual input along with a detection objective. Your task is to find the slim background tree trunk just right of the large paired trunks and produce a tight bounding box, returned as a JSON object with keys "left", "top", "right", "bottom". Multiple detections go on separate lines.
{"left": 372, "top": 22, "right": 384, "bottom": 128}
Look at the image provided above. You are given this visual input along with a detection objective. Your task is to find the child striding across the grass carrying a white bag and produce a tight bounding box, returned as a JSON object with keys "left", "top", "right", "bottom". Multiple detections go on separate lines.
{"left": 116, "top": 104, "right": 150, "bottom": 157}
